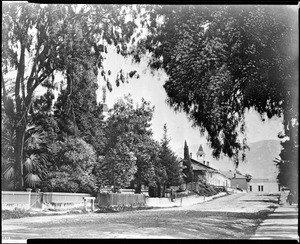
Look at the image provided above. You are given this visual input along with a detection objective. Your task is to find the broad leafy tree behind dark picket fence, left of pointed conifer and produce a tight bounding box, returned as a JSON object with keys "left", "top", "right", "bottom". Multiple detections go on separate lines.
{"left": 103, "top": 95, "right": 154, "bottom": 191}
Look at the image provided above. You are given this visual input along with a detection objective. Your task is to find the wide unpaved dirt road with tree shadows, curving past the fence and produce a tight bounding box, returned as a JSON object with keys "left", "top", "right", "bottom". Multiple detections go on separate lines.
{"left": 2, "top": 193, "right": 277, "bottom": 240}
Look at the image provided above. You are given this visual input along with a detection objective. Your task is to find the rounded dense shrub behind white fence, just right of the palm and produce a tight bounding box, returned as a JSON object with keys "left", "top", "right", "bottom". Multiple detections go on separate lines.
{"left": 42, "top": 137, "right": 97, "bottom": 193}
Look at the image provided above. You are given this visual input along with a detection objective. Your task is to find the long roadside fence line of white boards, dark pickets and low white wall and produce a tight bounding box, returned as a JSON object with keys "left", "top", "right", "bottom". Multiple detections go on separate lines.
{"left": 1, "top": 191, "right": 226, "bottom": 209}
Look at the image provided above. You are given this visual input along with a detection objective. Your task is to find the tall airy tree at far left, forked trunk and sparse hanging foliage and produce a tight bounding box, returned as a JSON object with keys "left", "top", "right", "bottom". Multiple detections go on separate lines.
{"left": 1, "top": 3, "right": 141, "bottom": 190}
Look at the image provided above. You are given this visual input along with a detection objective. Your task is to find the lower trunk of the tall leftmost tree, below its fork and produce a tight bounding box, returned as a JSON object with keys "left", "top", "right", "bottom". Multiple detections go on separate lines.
{"left": 15, "top": 123, "right": 26, "bottom": 190}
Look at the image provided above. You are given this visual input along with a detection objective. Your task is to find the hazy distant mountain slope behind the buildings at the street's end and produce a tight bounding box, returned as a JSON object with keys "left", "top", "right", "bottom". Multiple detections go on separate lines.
{"left": 175, "top": 140, "right": 281, "bottom": 179}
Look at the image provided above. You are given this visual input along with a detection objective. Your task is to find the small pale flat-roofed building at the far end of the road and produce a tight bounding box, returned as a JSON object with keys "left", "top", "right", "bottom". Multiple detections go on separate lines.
{"left": 248, "top": 179, "right": 280, "bottom": 193}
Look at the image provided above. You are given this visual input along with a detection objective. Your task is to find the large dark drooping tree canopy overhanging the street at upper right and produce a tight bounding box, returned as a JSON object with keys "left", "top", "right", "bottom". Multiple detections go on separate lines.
{"left": 136, "top": 5, "right": 297, "bottom": 164}
